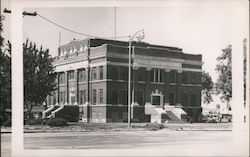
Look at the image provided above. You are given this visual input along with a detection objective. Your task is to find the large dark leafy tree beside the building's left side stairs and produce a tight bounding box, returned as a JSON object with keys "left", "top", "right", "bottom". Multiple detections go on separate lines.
{"left": 23, "top": 40, "right": 56, "bottom": 118}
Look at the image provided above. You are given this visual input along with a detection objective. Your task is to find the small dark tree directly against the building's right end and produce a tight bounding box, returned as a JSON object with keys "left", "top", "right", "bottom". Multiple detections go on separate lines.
{"left": 201, "top": 71, "right": 214, "bottom": 104}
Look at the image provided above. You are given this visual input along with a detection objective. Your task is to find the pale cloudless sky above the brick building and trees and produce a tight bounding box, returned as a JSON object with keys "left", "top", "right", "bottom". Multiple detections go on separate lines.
{"left": 0, "top": 0, "right": 249, "bottom": 108}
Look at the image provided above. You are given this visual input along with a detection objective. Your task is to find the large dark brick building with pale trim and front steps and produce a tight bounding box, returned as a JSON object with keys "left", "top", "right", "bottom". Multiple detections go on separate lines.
{"left": 43, "top": 39, "right": 202, "bottom": 122}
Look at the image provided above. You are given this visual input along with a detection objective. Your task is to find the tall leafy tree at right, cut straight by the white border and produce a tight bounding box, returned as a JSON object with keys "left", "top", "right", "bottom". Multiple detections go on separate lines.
{"left": 215, "top": 45, "right": 232, "bottom": 110}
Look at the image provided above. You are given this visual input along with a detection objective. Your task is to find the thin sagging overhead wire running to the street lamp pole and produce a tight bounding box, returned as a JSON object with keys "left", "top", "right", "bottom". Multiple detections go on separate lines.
{"left": 37, "top": 13, "right": 129, "bottom": 39}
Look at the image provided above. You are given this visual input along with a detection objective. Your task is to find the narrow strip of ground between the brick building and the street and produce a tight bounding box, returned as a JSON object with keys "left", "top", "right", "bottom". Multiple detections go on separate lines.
{"left": 1, "top": 123, "right": 232, "bottom": 133}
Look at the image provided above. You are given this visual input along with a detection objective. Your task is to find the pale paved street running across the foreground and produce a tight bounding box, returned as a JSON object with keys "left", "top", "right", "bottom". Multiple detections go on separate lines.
{"left": 1, "top": 129, "right": 232, "bottom": 157}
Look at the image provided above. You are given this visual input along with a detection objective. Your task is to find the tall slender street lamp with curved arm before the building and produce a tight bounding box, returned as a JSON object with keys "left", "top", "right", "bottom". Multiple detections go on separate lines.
{"left": 128, "top": 29, "right": 145, "bottom": 127}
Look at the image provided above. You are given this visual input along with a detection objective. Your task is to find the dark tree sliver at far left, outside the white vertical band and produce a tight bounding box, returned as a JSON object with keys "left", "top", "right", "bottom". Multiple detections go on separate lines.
{"left": 0, "top": 16, "right": 11, "bottom": 124}
